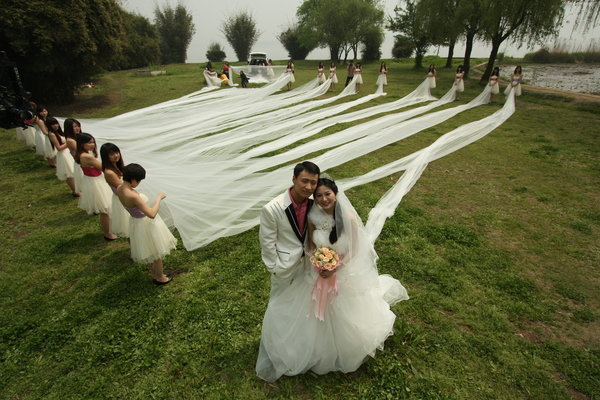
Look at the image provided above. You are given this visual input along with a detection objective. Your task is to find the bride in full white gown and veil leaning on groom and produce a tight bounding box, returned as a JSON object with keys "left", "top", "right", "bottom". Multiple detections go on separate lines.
{"left": 256, "top": 175, "right": 408, "bottom": 382}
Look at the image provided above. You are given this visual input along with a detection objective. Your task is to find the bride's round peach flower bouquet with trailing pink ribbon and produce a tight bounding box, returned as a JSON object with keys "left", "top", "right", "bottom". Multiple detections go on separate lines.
{"left": 310, "top": 247, "right": 340, "bottom": 321}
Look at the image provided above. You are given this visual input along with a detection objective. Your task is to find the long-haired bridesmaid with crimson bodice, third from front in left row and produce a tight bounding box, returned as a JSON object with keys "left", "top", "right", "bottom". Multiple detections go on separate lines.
{"left": 75, "top": 133, "right": 118, "bottom": 241}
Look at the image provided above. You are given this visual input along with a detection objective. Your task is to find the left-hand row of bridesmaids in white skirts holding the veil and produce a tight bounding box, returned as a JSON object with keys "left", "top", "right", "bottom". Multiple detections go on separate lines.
{"left": 16, "top": 111, "right": 177, "bottom": 285}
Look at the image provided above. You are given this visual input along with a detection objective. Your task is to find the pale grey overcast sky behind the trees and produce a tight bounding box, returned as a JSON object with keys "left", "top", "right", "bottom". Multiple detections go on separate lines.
{"left": 121, "top": 0, "right": 600, "bottom": 63}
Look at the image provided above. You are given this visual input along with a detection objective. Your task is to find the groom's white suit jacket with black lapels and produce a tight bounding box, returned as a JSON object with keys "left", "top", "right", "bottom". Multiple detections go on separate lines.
{"left": 259, "top": 190, "right": 313, "bottom": 293}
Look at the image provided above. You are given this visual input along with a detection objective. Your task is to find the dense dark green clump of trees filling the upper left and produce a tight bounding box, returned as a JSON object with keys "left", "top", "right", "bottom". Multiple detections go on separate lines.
{"left": 0, "top": 0, "right": 194, "bottom": 103}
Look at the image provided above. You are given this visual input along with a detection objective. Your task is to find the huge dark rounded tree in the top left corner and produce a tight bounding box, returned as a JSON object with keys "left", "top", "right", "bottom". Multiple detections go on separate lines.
{"left": 0, "top": 0, "right": 126, "bottom": 103}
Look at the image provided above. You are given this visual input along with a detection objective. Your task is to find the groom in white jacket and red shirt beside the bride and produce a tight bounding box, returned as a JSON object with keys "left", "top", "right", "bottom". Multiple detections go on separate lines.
{"left": 259, "top": 161, "right": 321, "bottom": 296}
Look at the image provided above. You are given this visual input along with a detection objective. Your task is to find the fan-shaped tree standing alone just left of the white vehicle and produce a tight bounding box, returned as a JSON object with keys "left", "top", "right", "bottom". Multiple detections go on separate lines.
{"left": 221, "top": 11, "right": 260, "bottom": 61}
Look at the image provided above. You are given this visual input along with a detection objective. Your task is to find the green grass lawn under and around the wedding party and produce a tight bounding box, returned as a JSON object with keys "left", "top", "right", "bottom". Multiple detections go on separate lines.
{"left": 0, "top": 59, "right": 600, "bottom": 400}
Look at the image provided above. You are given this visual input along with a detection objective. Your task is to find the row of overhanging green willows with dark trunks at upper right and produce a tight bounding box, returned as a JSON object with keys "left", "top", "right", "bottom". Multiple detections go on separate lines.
{"left": 386, "top": 0, "right": 568, "bottom": 82}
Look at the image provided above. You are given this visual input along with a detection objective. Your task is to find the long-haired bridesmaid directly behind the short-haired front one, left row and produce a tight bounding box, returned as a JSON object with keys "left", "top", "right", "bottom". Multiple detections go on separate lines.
{"left": 100, "top": 143, "right": 131, "bottom": 237}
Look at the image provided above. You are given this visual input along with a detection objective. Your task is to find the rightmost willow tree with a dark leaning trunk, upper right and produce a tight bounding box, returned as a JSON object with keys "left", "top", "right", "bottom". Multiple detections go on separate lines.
{"left": 481, "top": 0, "right": 565, "bottom": 82}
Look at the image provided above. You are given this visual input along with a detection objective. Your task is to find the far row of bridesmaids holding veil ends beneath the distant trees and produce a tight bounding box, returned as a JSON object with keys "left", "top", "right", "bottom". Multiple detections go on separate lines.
{"left": 317, "top": 61, "right": 523, "bottom": 102}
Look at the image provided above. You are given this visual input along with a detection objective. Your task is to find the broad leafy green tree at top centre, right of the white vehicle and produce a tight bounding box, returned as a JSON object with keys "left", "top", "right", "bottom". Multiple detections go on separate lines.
{"left": 296, "top": 0, "right": 384, "bottom": 61}
